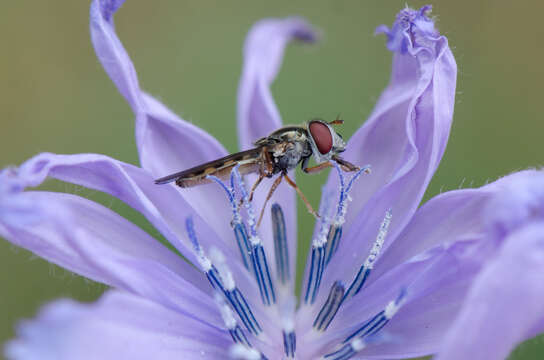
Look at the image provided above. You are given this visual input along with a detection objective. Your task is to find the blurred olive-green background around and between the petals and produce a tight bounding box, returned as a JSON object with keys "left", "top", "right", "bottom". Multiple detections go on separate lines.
{"left": 0, "top": 0, "right": 544, "bottom": 359}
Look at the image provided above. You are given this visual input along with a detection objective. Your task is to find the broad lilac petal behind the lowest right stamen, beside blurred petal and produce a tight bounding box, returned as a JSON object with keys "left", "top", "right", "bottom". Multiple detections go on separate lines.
{"left": 318, "top": 241, "right": 488, "bottom": 359}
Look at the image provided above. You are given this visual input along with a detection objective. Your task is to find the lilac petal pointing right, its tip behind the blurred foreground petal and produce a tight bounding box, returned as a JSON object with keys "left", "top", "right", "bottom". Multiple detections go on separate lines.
{"left": 369, "top": 170, "right": 539, "bottom": 281}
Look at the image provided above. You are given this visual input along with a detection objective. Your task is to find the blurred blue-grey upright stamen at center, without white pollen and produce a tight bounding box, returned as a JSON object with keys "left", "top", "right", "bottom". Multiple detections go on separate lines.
{"left": 272, "top": 204, "right": 291, "bottom": 285}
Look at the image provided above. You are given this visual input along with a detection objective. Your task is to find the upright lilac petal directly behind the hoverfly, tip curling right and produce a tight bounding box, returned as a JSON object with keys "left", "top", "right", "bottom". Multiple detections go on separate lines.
{"left": 238, "top": 18, "right": 316, "bottom": 276}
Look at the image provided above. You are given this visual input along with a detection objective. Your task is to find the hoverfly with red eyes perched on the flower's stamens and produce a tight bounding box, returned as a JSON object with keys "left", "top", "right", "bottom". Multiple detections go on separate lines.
{"left": 155, "top": 119, "right": 359, "bottom": 224}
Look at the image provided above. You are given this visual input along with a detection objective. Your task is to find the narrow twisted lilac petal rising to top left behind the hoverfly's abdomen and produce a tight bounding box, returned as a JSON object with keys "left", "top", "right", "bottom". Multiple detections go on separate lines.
{"left": 90, "top": 0, "right": 234, "bottom": 239}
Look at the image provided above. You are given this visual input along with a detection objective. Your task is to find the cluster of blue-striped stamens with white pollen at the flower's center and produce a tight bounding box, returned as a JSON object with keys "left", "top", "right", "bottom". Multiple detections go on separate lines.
{"left": 185, "top": 163, "right": 405, "bottom": 360}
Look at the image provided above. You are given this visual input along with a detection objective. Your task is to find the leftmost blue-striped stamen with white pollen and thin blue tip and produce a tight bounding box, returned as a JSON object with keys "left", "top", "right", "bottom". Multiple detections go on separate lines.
{"left": 185, "top": 217, "right": 262, "bottom": 335}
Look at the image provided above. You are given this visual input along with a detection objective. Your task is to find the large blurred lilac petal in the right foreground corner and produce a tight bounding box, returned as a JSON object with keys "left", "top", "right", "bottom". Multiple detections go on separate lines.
{"left": 438, "top": 171, "right": 544, "bottom": 360}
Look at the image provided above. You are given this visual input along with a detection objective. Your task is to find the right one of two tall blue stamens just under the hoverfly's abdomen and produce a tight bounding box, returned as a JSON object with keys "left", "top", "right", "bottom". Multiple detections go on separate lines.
{"left": 231, "top": 166, "right": 276, "bottom": 305}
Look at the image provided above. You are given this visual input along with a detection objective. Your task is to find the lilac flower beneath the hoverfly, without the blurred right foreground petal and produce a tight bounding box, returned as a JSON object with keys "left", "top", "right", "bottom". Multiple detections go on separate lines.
{"left": 0, "top": 0, "right": 528, "bottom": 360}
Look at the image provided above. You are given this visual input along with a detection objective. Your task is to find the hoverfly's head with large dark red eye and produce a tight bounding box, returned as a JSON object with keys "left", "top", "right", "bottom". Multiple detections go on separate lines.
{"left": 308, "top": 119, "right": 346, "bottom": 163}
